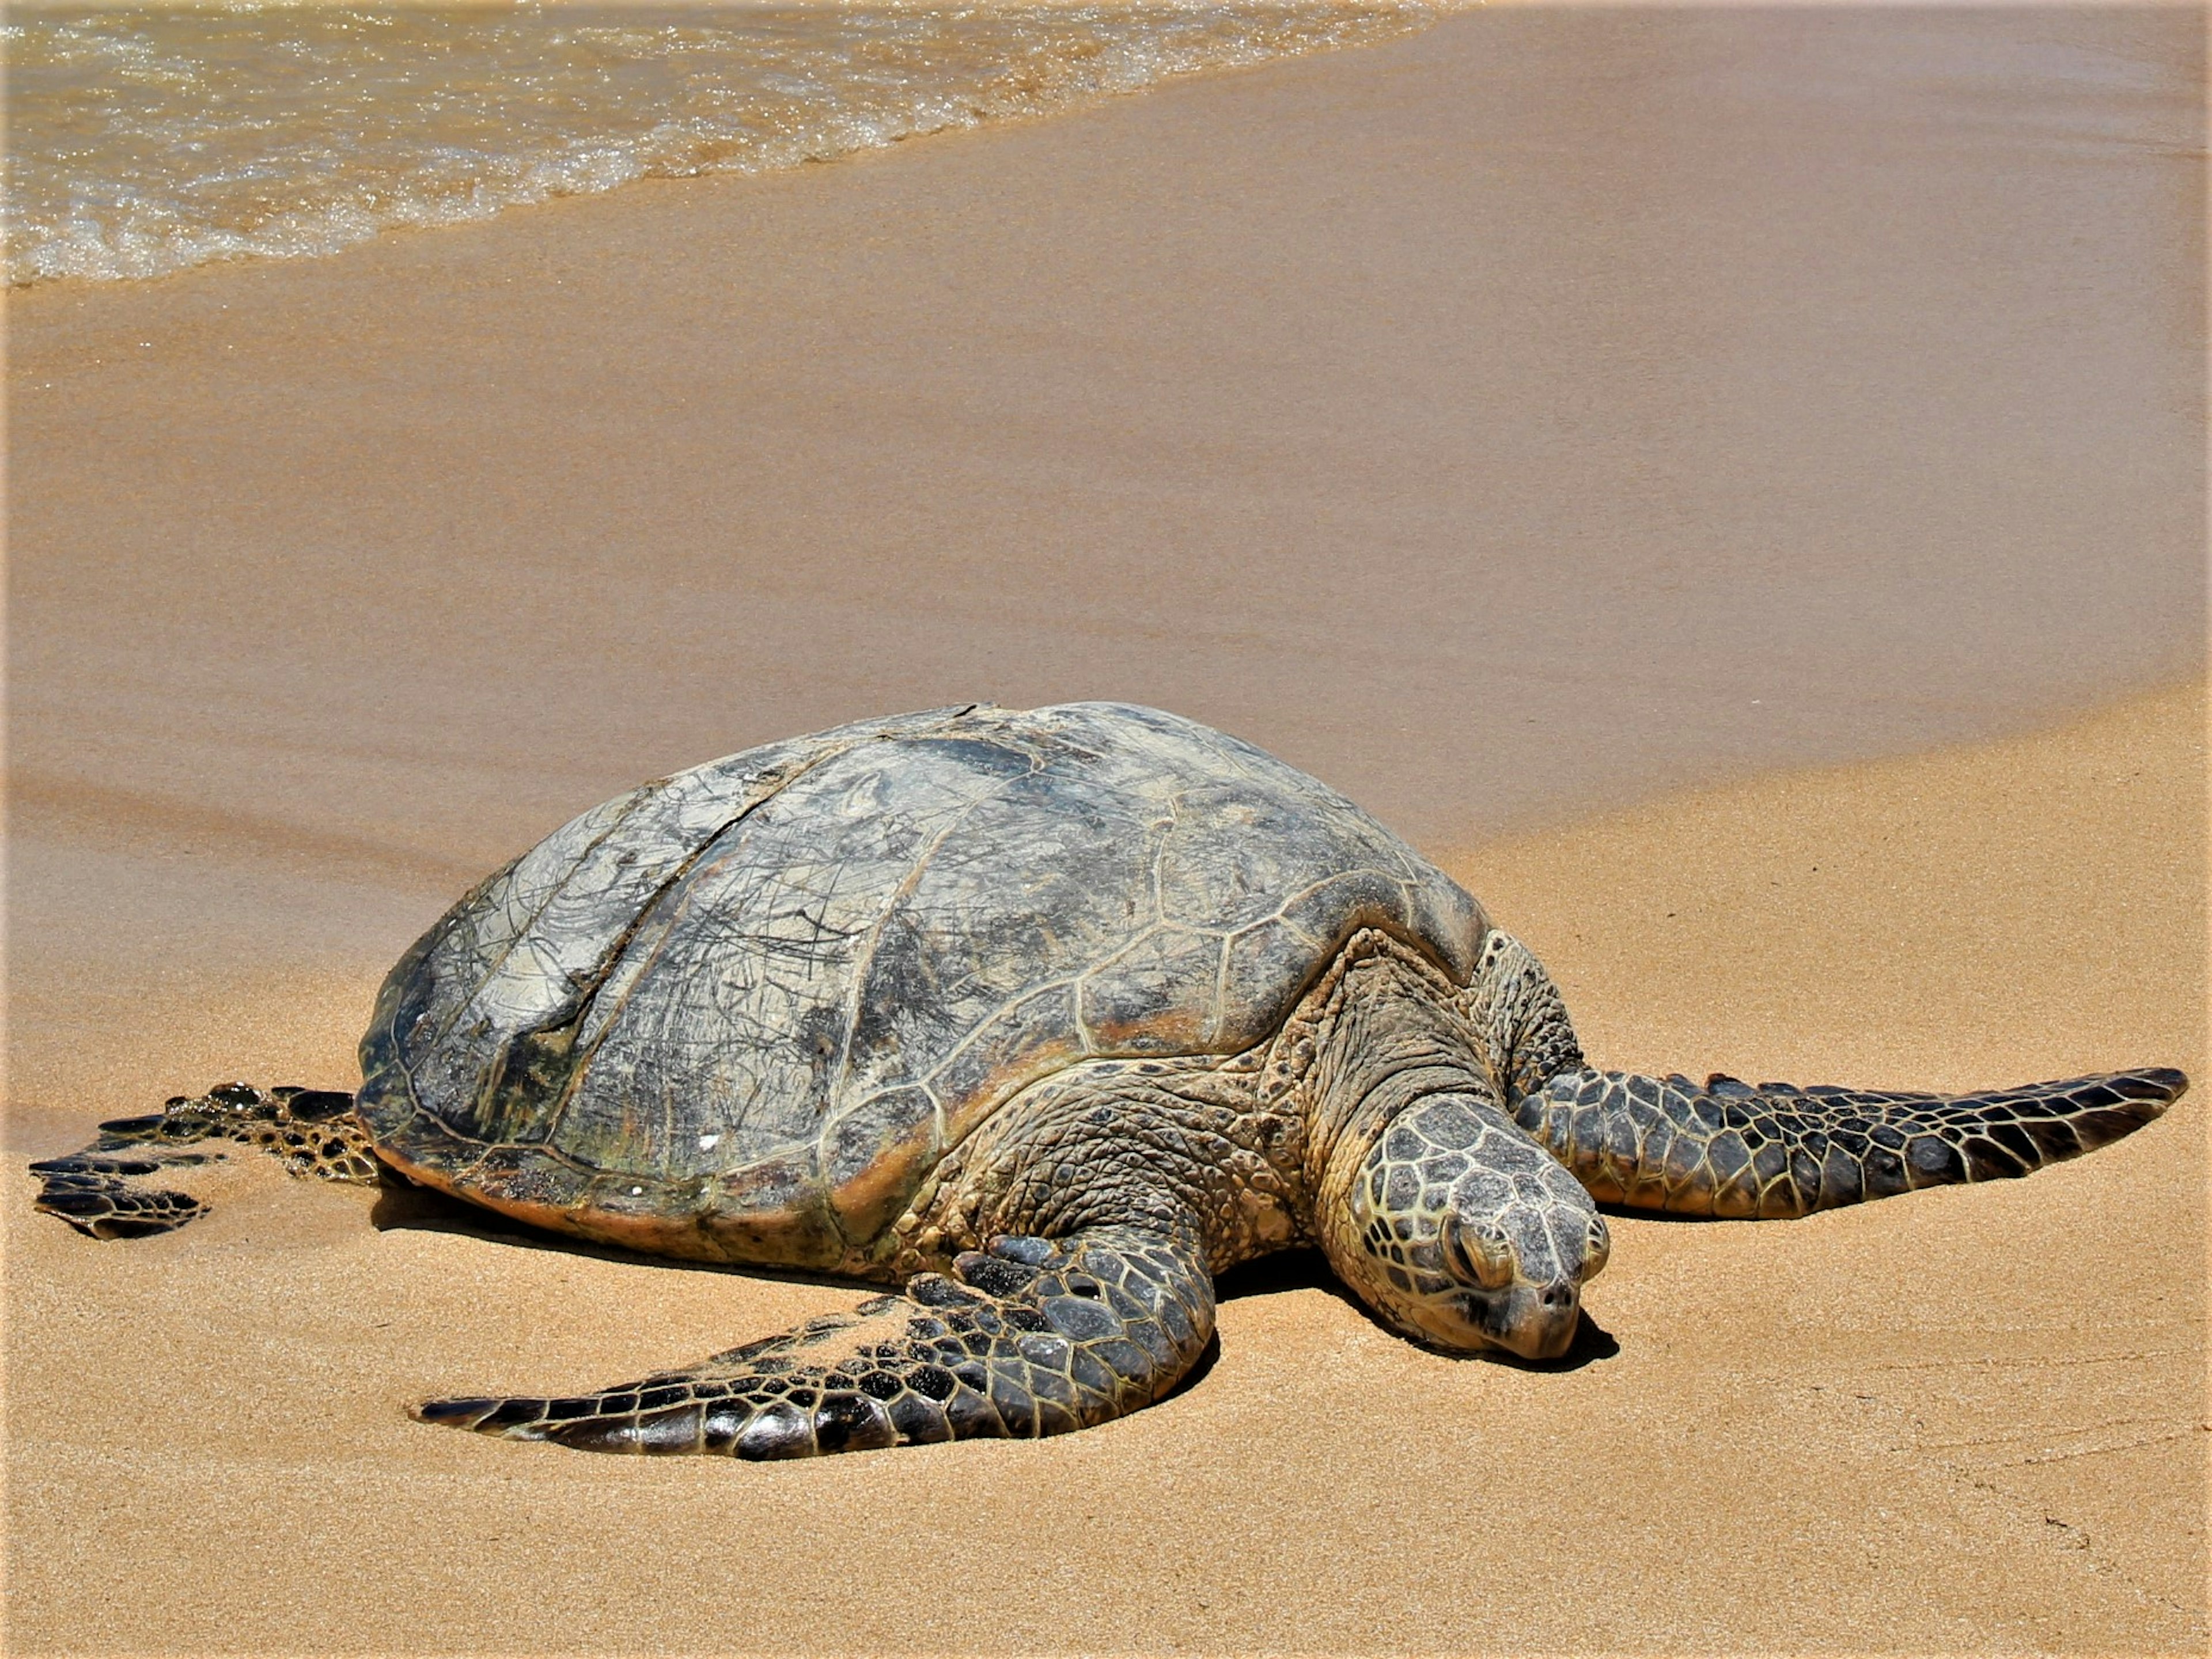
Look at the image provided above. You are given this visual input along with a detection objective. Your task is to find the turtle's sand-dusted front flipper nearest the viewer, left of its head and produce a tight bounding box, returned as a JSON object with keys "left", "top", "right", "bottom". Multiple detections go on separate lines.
{"left": 414, "top": 1228, "right": 1214, "bottom": 1460}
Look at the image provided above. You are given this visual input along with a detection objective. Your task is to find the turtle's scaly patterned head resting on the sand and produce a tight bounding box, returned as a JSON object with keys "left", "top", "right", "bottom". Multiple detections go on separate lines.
{"left": 1320, "top": 1095, "right": 1608, "bottom": 1361}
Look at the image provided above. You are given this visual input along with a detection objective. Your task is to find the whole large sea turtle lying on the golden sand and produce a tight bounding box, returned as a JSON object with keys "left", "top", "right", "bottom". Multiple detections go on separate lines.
{"left": 33, "top": 703, "right": 2186, "bottom": 1458}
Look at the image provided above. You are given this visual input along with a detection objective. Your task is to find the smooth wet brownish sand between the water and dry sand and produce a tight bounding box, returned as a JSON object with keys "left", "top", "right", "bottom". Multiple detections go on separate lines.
{"left": 9, "top": 11, "right": 2203, "bottom": 863}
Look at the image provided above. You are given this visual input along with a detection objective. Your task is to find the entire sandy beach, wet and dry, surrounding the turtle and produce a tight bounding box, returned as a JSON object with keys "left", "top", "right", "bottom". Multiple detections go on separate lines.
{"left": 0, "top": 9, "right": 2212, "bottom": 1654}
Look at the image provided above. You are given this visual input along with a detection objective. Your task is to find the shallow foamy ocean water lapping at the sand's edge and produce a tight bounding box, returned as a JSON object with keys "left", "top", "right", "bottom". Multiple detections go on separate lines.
{"left": 0, "top": 0, "right": 1427, "bottom": 285}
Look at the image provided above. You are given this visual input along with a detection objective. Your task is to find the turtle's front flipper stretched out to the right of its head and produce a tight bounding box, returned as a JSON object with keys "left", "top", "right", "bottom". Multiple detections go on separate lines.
{"left": 1513, "top": 1066, "right": 2188, "bottom": 1219}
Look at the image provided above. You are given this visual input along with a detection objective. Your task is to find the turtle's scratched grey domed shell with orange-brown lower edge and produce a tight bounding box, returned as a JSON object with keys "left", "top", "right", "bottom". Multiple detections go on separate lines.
{"left": 361, "top": 703, "right": 1486, "bottom": 1267}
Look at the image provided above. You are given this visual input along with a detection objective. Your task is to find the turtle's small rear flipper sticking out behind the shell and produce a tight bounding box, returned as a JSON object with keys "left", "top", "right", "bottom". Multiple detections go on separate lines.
{"left": 31, "top": 1084, "right": 378, "bottom": 1238}
